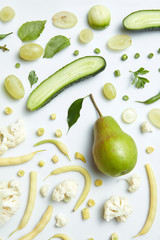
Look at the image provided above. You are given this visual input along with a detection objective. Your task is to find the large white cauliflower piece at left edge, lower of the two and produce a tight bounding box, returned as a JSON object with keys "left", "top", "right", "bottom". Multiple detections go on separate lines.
{"left": 0, "top": 180, "right": 21, "bottom": 226}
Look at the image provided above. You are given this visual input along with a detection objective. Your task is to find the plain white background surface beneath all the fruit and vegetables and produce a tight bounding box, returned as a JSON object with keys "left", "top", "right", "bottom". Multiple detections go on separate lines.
{"left": 0, "top": 0, "right": 160, "bottom": 240}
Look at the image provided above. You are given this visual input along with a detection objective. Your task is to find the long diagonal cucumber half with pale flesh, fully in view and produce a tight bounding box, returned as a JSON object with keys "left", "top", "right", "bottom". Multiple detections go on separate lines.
{"left": 27, "top": 56, "right": 106, "bottom": 111}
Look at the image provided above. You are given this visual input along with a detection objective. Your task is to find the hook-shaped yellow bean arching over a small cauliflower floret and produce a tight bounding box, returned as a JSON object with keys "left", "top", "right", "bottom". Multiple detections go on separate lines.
{"left": 44, "top": 165, "right": 91, "bottom": 211}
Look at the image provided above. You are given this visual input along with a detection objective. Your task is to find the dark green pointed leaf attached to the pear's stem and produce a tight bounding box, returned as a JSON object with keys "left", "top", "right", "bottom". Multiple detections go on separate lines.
{"left": 67, "top": 98, "right": 85, "bottom": 131}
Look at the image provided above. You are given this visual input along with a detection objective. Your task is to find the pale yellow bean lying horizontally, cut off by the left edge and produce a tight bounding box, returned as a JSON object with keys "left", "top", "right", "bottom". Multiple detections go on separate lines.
{"left": 0, "top": 150, "right": 45, "bottom": 166}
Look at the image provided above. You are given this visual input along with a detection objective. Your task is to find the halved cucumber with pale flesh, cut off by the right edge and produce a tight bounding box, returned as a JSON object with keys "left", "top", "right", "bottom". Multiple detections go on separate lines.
{"left": 123, "top": 9, "right": 160, "bottom": 30}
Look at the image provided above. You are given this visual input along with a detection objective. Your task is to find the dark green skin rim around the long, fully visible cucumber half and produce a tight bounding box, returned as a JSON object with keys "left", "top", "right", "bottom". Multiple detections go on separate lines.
{"left": 27, "top": 56, "right": 107, "bottom": 111}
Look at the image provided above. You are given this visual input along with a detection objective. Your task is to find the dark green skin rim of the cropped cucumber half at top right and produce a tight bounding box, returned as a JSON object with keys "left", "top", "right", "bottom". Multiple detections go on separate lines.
{"left": 122, "top": 9, "right": 160, "bottom": 32}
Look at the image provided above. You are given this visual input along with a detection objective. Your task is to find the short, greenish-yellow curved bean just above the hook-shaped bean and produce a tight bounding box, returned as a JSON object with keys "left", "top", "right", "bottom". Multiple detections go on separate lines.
{"left": 34, "top": 139, "right": 71, "bottom": 160}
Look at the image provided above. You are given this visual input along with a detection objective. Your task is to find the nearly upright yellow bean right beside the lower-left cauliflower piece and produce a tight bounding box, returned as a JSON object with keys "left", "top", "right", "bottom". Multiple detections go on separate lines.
{"left": 10, "top": 172, "right": 37, "bottom": 236}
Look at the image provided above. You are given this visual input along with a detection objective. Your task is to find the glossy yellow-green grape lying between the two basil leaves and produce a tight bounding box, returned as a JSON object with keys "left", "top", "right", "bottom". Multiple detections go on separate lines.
{"left": 19, "top": 43, "right": 43, "bottom": 61}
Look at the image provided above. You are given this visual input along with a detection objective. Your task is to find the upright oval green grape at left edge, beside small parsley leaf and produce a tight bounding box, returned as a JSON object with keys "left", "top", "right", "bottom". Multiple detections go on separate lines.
{"left": 4, "top": 75, "right": 25, "bottom": 99}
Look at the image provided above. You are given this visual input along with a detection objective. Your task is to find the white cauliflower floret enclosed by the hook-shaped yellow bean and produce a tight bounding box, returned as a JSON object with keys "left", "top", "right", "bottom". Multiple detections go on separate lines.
{"left": 52, "top": 180, "right": 78, "bottom": 202}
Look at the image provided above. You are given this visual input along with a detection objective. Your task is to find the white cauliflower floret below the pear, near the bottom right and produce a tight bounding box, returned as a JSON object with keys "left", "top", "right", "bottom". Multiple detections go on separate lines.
{"left": 104, "top": 196, "right": 132, "bottom": 222}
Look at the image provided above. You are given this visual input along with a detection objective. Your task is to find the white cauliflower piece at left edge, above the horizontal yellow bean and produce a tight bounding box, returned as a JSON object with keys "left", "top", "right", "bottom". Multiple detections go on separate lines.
{"left": 0, "top": 119, "right": 26, "bottom": 155}
